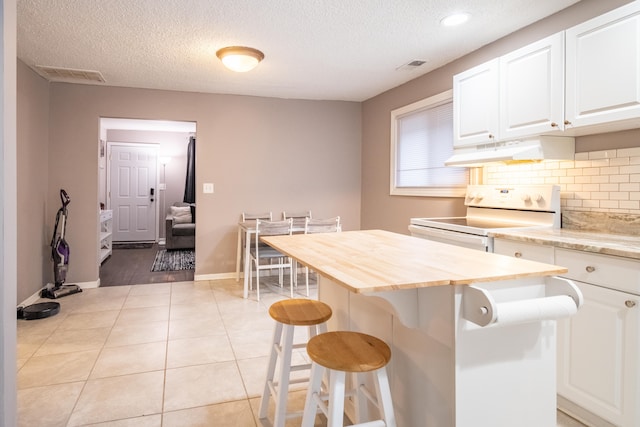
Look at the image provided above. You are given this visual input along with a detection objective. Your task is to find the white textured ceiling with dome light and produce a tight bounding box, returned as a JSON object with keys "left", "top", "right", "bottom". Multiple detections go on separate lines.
{"left": 17, "top": 0, "right": 578, "bottom": 101}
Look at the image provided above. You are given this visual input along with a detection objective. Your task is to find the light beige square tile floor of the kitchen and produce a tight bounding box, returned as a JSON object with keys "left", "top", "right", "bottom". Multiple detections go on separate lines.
{"left": 17, "top": 280, "right": 581, "bottom": 427}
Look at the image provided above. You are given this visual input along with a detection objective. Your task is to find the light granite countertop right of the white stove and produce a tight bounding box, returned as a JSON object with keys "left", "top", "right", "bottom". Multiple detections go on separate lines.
{"left": 490, "top": 228, "right": 640, "bottom": 260}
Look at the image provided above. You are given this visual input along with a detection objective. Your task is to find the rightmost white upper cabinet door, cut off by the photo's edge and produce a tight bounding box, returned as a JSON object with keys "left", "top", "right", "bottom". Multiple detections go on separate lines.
{"left": 566, "top": 1, "right": 640, "bottom": 127}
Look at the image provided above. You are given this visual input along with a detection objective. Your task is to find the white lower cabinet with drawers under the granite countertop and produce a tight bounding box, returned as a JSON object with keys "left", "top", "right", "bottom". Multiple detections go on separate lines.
{"left": 494, "top": 239, "right": 640, "bottom": 427}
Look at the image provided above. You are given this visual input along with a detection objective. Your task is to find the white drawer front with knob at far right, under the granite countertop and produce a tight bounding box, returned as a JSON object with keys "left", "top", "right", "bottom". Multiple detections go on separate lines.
{"left": 555, "top": 248, "right": 640, "bottom": 295}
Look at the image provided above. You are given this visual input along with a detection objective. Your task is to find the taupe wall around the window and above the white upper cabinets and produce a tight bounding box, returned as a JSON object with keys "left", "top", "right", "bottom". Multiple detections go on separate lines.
{"left": 362, "top": 0, "right": 629, "bottom": 234}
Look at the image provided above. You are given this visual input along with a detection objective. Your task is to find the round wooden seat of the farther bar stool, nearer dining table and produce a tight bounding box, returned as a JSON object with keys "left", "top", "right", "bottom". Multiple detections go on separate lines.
{"left": 269, "top": 298, "right": 331, "bottom": 326}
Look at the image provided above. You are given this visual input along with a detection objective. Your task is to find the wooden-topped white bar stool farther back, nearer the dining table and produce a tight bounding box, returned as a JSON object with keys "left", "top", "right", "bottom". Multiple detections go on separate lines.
{"left": 259, "top": 299, "right": 332, "bottom": 427}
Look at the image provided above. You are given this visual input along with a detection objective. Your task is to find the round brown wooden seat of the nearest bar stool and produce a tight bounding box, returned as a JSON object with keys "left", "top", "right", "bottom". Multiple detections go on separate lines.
{"left": 307, "top": 331, "right": 391, "bottom": 372}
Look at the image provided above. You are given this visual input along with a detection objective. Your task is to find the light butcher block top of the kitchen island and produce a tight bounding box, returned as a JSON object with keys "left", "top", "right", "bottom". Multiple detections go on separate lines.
{"left": 261, "top": 230, "right": 568, "bottom": 293}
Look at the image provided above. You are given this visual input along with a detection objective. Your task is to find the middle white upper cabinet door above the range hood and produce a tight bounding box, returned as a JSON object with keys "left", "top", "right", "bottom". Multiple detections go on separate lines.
{"left": 500, "top": 33, "right": 564, "bottom": 140}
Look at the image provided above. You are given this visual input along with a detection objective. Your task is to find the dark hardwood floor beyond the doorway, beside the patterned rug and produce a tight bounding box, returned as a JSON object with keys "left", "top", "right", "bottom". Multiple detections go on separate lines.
{"left": 100, "top": 244, "right": 194, "bottom": 286}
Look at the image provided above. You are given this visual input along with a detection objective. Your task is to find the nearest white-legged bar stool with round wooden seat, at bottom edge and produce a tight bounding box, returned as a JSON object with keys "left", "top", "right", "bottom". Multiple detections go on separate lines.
{"left": 302, "top": 331, "right": 396, "bottom": 427}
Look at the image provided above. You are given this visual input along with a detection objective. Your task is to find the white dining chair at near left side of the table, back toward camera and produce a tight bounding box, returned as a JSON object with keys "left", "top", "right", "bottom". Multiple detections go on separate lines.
{"left": 249, "top": 219, "right": 294, "bottom": 301}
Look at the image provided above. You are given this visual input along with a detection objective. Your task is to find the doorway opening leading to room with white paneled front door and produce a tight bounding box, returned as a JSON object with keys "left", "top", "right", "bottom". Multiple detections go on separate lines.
{"left": 98, "top": 118, "right": 196, "bottom": 286}
